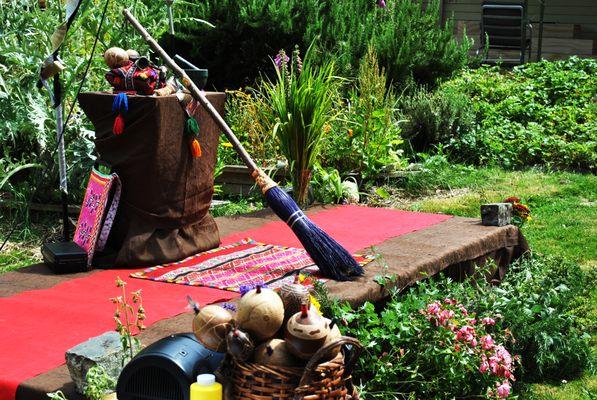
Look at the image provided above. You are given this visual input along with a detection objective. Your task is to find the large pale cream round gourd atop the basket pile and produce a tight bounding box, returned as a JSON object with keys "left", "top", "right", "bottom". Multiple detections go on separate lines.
{"left": 236, "top": 286, "right": 284, "bottom": 342}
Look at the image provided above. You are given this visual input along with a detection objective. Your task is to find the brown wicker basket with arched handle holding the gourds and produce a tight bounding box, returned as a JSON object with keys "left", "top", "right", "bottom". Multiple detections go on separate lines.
{"left": 222, "top": 336, "right": 362, "bottom": 400}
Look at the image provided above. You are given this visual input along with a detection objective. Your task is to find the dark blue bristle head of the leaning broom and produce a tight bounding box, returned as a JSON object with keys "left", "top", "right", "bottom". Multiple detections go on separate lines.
{"left": 265, "top": 186, "right": 364, "bottom": 281}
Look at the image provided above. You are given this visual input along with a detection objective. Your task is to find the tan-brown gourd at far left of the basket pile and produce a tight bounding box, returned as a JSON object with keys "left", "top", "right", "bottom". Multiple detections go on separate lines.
{"left": 193, "top": 305, "right": 232, "bottom": 353}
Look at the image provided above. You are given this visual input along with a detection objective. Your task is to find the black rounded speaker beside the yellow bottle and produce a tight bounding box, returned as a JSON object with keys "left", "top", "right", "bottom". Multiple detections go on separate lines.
{"left": 116, "top": 333, "right": 224, "bottom": 400}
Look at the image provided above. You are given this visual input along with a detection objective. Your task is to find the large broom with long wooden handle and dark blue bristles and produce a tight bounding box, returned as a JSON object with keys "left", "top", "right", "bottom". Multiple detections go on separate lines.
{"left": 123, "top": 9, "right": 363, "bottom": 281}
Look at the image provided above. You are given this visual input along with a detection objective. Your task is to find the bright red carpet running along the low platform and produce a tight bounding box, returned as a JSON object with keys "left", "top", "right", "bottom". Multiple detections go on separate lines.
{"left": 0, "top": 206, "right": 450, "bottom": 400}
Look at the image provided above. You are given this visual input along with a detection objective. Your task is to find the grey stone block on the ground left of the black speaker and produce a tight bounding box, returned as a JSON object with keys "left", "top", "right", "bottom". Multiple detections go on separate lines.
{"left": 65, "top": 332, "right": 137, "bottom": 393}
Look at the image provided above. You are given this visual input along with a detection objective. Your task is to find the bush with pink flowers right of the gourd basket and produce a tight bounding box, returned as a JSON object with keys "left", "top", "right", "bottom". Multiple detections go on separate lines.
{"left": 331, "top": 282, "right": 519, "bottom": 399}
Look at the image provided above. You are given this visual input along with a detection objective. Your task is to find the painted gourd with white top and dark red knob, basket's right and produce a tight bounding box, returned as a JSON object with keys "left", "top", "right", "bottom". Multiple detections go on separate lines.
{"left": 284, "top": 304, "right": 330, "bottom": 360}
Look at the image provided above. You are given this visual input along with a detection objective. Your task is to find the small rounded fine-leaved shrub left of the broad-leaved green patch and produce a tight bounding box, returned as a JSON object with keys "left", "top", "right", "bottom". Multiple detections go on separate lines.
{"left": 399, "top": 88, "right": 475, "bottom": 152}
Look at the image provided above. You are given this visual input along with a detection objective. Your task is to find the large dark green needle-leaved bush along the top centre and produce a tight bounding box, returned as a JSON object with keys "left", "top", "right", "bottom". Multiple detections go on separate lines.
{"left": 173, "top": 0, "right": 470, "bottom": 88}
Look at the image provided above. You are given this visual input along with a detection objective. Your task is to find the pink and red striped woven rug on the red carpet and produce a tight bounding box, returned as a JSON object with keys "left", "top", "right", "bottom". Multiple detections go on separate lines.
{"left": 131, "top": 238, "right": 374, "bottom": 292}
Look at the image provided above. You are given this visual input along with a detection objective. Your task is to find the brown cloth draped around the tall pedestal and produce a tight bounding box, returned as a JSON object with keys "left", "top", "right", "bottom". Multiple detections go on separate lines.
{"left": 79, "top": 92, "right": 225, "bottom": 267}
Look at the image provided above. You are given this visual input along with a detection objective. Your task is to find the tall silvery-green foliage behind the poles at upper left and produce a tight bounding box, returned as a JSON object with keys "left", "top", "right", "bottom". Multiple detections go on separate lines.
{"left": 0, "top": 0, "right": 171, "bottom": 211}
